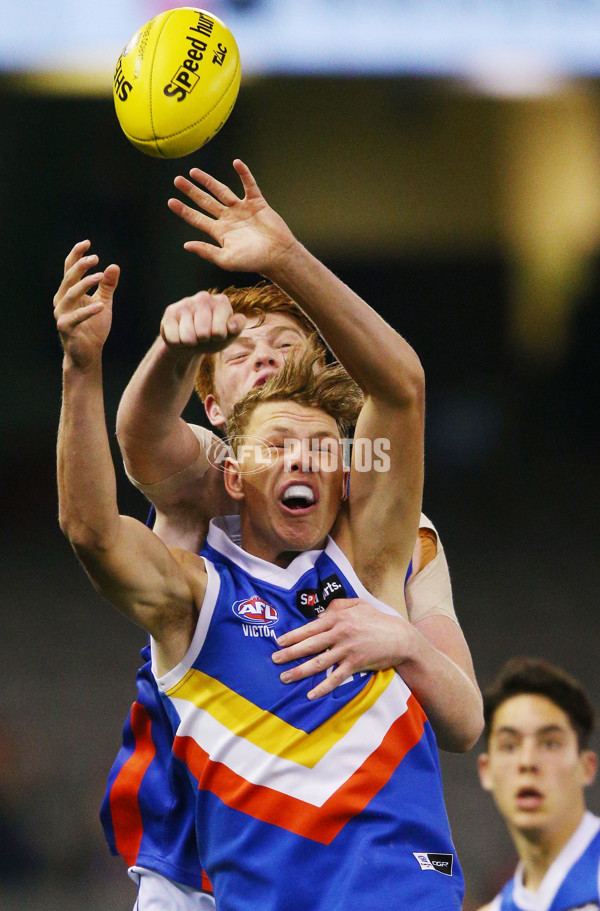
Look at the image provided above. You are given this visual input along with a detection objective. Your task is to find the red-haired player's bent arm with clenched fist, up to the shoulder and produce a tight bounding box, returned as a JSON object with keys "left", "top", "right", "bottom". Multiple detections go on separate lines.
{"left": 117, "top": 292, "right": 245, "bottom": 551}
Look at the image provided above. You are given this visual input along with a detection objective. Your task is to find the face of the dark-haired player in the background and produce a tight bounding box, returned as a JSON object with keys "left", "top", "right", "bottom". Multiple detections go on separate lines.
{"left": 479, "top": 694, "right": 596, "bottom": 835}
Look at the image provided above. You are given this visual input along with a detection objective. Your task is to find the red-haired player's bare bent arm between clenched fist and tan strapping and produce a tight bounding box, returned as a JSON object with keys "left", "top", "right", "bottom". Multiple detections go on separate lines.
{"left": 117, "top": 336, "right": 199, "bottom": 484}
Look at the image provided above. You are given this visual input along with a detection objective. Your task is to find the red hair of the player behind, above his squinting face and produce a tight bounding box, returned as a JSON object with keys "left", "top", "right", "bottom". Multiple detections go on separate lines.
{"left": 194, "top": 282, "right": 324, "bottom": 402}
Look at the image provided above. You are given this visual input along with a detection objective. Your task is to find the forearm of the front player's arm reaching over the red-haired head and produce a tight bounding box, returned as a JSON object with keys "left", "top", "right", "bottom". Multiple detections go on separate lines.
{"left": 267, "top": 241, "right": 422, "bottom": 404}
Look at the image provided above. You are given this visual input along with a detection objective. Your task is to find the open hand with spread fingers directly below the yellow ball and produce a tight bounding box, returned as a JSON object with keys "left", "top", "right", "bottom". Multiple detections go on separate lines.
{"left": 168, "top": 158, "right": 296, "bottom": 276}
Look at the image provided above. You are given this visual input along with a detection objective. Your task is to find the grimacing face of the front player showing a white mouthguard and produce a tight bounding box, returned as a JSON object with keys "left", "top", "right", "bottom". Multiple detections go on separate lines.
{"left": 228, "top": 402, "right": 345, "bottom": 566}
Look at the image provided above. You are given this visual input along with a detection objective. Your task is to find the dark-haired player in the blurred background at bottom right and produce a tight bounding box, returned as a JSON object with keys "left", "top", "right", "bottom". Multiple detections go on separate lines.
{"left": 479, "top": 658, "right": 600, "bottom": 911}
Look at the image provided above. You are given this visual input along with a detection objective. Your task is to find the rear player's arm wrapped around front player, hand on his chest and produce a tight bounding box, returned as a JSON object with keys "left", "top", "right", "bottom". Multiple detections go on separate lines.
{"left": 273, "top": 517, "right": 483, "bottom": 752}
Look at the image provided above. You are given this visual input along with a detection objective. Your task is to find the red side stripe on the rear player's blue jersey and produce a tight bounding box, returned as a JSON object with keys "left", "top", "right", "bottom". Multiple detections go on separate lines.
{"left": 110, "top": 702, "right": 156, "bottom": 866}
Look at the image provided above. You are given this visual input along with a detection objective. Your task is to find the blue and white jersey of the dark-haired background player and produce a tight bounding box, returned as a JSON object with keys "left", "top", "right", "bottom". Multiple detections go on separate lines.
{"left": 490, "top": 812, "right": 600, "bottom": 911}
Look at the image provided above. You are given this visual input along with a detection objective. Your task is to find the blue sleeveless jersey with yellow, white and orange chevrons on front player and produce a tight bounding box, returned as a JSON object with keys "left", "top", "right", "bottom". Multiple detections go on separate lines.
{"left": 158, "top": 517, "right": 463, "bottom": 911}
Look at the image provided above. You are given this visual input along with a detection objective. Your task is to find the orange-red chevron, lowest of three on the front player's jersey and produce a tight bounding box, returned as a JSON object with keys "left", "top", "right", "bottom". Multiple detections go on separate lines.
{"left": 173, "top": 695, "right": 426, "bottom": 845}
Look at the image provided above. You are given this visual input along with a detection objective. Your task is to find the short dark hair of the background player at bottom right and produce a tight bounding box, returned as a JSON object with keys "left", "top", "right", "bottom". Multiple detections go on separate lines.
{"left": 483, "top": 657, "right": 596, "bottom": 750}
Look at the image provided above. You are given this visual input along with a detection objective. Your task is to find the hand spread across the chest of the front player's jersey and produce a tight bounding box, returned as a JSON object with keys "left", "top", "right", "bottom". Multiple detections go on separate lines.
{"left": 272, "top": 598, "right": 414, "bottom": 699}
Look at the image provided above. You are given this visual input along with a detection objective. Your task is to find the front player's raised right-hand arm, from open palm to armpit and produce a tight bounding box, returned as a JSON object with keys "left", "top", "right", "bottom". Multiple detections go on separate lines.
{"left": 169, "top": 159, "right": 424, "bottom": 580}
